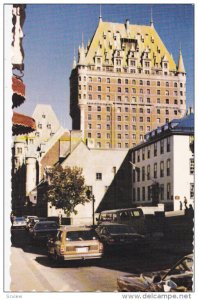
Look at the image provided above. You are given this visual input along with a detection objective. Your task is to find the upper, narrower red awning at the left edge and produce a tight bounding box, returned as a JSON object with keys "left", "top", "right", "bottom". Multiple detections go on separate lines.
{"left": 12, "top": 76, "right": 25, "bottom": 108}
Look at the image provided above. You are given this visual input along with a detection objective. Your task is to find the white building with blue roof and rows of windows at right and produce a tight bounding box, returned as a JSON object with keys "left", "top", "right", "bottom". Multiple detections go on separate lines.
{"left": 132, "top": 113, "right": 194, "bottom": 210}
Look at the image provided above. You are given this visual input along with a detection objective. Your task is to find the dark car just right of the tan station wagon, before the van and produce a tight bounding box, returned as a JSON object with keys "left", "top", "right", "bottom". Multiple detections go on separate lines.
{"left": 96, "top": 223, "right": 146, "bottom": 250}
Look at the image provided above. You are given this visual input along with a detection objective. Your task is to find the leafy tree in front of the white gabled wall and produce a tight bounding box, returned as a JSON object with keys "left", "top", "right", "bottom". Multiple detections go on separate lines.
{"left": 46, "top": 165, "right": 91, "bottom": 214}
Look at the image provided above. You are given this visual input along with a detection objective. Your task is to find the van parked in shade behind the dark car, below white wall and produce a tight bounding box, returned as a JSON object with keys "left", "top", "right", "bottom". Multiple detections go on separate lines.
{"left": 96, "top": 208, "right": 145, "bottom": 233}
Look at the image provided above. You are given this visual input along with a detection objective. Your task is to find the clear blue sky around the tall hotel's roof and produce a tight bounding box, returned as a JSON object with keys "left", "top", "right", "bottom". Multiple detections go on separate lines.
{"left": 16, "top": 4, "right": 194, "bottom": 129}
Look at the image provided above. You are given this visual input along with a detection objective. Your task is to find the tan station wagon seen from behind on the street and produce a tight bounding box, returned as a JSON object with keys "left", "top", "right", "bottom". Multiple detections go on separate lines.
{"left": 48, "top": 225, "right": 103, "bottom": 262}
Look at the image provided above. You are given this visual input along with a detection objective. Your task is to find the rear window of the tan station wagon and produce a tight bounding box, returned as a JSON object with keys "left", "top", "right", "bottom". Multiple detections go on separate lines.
{"left": 66, "top": 230, "right": 97, "bottom": 241}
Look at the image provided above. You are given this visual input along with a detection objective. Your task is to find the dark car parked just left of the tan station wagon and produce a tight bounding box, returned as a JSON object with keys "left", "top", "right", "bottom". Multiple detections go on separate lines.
{"left": 29, "top": 221, "right": 58, "bottom": 242}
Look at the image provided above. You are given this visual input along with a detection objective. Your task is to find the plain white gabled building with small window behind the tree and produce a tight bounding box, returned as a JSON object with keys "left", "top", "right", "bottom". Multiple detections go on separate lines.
{"left": 62, "top": 142, "right": 131, "bottom": 224}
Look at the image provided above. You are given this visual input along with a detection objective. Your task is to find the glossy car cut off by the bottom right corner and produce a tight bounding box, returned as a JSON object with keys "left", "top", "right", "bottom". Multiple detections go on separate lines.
{"left": 117, "top": 254, "right": 193, "bottom": 292}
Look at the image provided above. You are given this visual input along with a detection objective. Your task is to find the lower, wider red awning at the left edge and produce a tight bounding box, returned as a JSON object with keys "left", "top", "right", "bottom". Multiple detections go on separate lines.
{"left": 12, "top": 112, "right": 36, "bottom": 135}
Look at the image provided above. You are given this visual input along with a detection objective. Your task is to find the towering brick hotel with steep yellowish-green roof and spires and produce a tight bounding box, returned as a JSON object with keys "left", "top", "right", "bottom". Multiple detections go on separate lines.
{"left": 70, "top": 17, "right": 186, "bottom": 149}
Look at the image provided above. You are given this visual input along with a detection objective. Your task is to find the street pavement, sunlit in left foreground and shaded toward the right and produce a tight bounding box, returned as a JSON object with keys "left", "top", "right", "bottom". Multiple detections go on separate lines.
{"left": 10, "top": 229, "right": 191, "bottom": 292}
